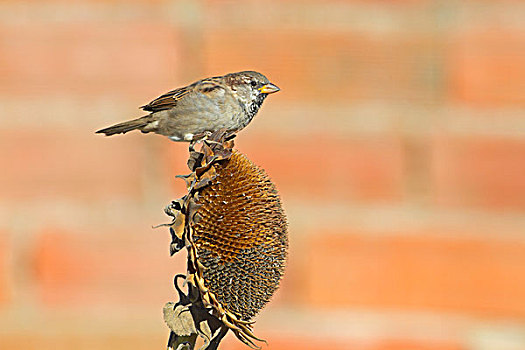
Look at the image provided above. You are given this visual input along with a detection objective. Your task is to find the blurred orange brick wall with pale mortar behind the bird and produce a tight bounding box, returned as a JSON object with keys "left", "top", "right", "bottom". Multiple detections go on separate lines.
{"left": 0, "top": 0, "right": 525, "bottom": 350}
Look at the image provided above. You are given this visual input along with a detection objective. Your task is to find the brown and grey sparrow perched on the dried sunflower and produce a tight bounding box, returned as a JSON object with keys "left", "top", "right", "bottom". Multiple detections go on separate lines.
{"left": 96, "top": 71, "right": 280, "bottom": 141}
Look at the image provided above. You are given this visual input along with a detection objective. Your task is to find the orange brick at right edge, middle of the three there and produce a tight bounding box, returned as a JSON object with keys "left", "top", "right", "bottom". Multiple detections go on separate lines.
{"left": 432, "top": 136, "right": 525, "bottom": 210}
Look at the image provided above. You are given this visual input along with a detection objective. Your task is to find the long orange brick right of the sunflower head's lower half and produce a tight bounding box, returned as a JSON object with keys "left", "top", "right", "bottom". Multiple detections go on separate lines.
{"left": 297, "top": 231, "right": 525, "bottom": 317}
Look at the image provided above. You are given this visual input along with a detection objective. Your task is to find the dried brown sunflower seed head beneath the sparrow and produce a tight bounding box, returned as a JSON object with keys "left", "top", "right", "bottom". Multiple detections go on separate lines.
{"left": 166, "top": 132, "right": 288, "bottom": 346}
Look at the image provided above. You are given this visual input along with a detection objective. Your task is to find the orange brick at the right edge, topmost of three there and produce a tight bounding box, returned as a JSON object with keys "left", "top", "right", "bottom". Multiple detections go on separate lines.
{"left": 448, "top": 29, "right": 525, "bottom": 106}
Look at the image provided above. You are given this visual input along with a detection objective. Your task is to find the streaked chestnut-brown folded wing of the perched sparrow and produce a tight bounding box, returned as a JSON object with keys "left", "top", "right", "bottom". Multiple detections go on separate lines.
{"left": 140, "top": 78, "right": 224, "bottom": 113}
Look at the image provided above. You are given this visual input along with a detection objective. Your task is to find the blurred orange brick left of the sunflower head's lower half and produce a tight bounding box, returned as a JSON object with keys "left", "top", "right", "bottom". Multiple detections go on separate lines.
{"left": 34, "top": 225, "right": 182, "bottom": 307}
